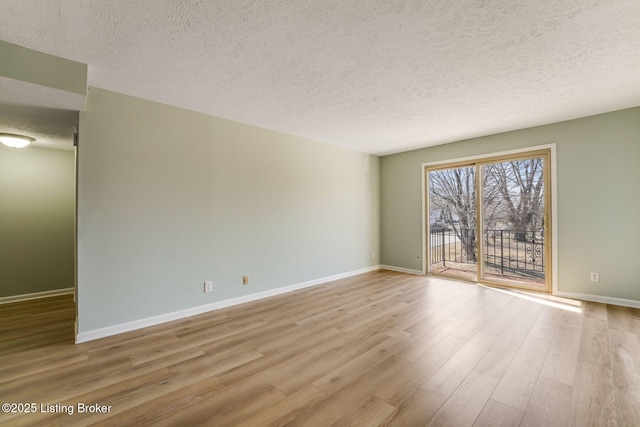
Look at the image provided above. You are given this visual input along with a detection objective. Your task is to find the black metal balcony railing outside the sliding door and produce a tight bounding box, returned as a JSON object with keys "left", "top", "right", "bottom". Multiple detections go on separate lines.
{"left": 429, "top": 228, "right": 545, "bottom": 278}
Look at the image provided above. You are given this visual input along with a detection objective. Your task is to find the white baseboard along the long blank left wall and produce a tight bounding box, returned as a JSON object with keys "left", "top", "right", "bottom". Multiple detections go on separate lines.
{"left": 76, "top": 265, "right": 380, "bottom": 344}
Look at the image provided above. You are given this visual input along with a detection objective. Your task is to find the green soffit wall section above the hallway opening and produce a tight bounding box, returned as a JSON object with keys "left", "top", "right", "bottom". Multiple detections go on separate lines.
{"left": 0, "top": 40, "right": 87, "bottom": 95}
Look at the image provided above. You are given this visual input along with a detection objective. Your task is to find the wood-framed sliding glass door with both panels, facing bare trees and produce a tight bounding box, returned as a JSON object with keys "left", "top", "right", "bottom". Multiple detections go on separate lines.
{"left": 425, "top": 150, "right": 551, "bottom": 291}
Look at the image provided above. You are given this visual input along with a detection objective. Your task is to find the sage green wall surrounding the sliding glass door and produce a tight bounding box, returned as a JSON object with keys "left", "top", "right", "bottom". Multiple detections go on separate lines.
{"left": 380, "top": 108, "right": 640, "bottom": 300}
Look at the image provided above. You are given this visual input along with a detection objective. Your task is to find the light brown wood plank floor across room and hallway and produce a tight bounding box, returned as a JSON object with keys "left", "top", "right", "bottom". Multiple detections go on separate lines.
{"left": 0, "top": 271, "right": 640, "bottom": 427}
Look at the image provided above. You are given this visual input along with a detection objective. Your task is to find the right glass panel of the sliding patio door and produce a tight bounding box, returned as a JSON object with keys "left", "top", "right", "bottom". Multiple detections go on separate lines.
{"left": 481, "top": 156, "right": 547, "bottom": 290}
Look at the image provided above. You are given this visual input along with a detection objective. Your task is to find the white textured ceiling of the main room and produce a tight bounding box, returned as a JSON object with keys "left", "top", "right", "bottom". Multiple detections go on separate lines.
{"left": 0, "top": 0, "right": 640, "bottom": 154}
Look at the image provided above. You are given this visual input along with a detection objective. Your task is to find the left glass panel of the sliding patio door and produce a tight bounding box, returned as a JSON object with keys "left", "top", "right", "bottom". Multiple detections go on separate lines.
{"left": 427, "top": 165, "right": 478, "bottom": 280}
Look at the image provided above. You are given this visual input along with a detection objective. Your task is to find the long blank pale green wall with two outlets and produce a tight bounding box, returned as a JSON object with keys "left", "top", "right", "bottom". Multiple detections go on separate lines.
{"left": 78, "top": 88, "right": 380, "bottom": 332}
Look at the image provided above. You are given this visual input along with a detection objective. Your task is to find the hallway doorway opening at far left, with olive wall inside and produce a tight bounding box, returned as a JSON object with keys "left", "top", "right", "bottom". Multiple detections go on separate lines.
{"left": 0, "top": 107, "right": 79, "bottom": 348}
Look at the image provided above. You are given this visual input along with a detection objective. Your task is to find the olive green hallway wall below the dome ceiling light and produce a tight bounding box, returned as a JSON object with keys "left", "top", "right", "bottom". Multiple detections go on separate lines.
{"left": 0, "top": 144, "right": 75, "bottom": 297}
